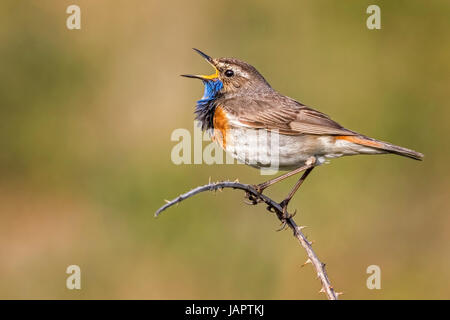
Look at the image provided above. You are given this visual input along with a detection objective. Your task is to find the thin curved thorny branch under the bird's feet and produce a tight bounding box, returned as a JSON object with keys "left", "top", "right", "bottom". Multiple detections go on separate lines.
{"left": 155, "top": 181, "right": 341, "bottom": 300}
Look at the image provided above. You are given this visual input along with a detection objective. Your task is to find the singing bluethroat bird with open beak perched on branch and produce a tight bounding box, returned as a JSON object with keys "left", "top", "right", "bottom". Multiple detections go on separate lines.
{"left": 182, "top": 49, "right": 423, "bottom": 218}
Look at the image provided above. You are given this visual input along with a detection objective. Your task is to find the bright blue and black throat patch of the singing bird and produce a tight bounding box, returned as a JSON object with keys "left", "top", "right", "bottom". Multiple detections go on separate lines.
{"left": 195, "top": 79, "right": 223, "bottom": 131}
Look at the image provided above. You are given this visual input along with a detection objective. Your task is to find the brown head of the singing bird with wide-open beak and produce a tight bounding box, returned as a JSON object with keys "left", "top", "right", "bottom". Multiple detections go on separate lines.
{"left": 182, "top": 49, "right": 271, "bottom": 94}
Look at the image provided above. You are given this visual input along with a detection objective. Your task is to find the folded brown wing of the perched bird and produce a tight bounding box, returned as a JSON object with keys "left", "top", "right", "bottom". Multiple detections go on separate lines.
{"left": 220, "top": 95, "right": 356, "bottom": 135}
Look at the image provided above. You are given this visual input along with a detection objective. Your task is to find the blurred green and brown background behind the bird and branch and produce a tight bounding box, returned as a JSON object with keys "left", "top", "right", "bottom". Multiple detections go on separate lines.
{"left": 0, "top": 0, "right": 450, "bottom": 299}
